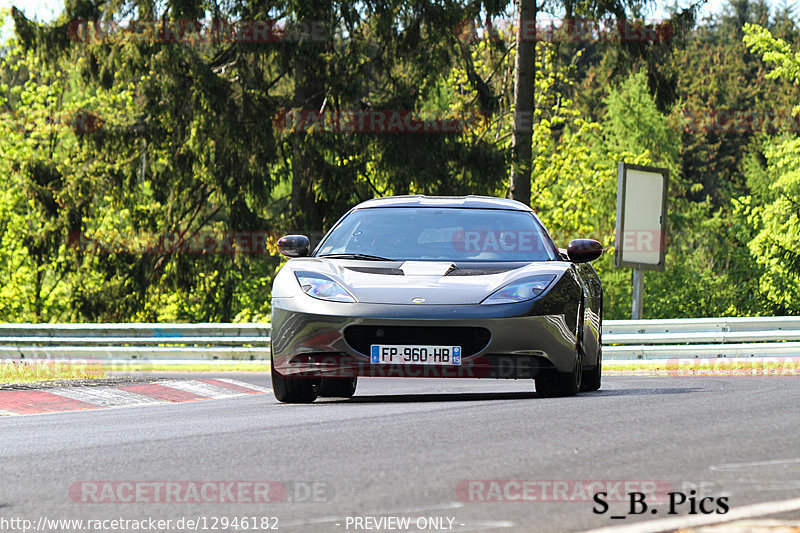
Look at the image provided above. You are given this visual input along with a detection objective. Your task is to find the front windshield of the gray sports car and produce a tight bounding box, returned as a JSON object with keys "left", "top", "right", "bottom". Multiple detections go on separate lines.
{"left": 315, "top": 207, "right": 557, "bottom": 262}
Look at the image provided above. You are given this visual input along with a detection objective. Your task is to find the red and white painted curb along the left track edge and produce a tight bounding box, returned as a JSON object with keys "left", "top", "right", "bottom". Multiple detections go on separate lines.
{"left": 0, "top": 378, "right": 270, "bottom": 416}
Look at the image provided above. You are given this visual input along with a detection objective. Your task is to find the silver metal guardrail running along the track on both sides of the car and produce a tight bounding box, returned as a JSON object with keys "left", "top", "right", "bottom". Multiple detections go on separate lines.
{"left": 0, "top": 317, "right": 800, "bottom": 362}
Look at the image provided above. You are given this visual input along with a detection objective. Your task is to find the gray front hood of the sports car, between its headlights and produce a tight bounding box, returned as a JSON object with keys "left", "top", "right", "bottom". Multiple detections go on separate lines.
{"left": 286, "top": 258, "right": 569, "bottom": 305}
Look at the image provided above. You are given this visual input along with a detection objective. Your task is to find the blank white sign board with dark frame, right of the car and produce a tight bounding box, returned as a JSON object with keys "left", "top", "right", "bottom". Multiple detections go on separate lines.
{"left": 614, "top": 162, "right": 669, "bottom": 270}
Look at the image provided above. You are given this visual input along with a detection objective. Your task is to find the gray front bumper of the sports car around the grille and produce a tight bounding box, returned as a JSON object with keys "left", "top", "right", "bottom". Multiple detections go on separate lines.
{"left": 271, "top": 298, "right": 578, "bottom": 378}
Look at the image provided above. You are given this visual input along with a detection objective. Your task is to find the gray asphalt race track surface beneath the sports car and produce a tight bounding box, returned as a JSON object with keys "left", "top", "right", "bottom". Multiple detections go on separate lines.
{"left": 0, "top": 374, "right": 800, "bottom": 532}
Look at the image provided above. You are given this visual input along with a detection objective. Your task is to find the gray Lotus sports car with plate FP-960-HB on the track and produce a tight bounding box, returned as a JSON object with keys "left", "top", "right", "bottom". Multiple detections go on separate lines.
{"left": 271, "top": 196, "right": 603, "bottom": 403}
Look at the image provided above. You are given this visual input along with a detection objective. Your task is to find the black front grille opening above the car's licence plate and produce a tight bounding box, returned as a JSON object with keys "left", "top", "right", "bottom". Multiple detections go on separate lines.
{"left": 344, "top": 326, "right": 491, "bottom": 357}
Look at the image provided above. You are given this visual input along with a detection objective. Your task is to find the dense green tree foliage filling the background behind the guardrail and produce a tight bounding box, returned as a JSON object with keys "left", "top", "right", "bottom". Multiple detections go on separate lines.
{"left": 0, "top": 0, "right": 800, "bottom": 321}
